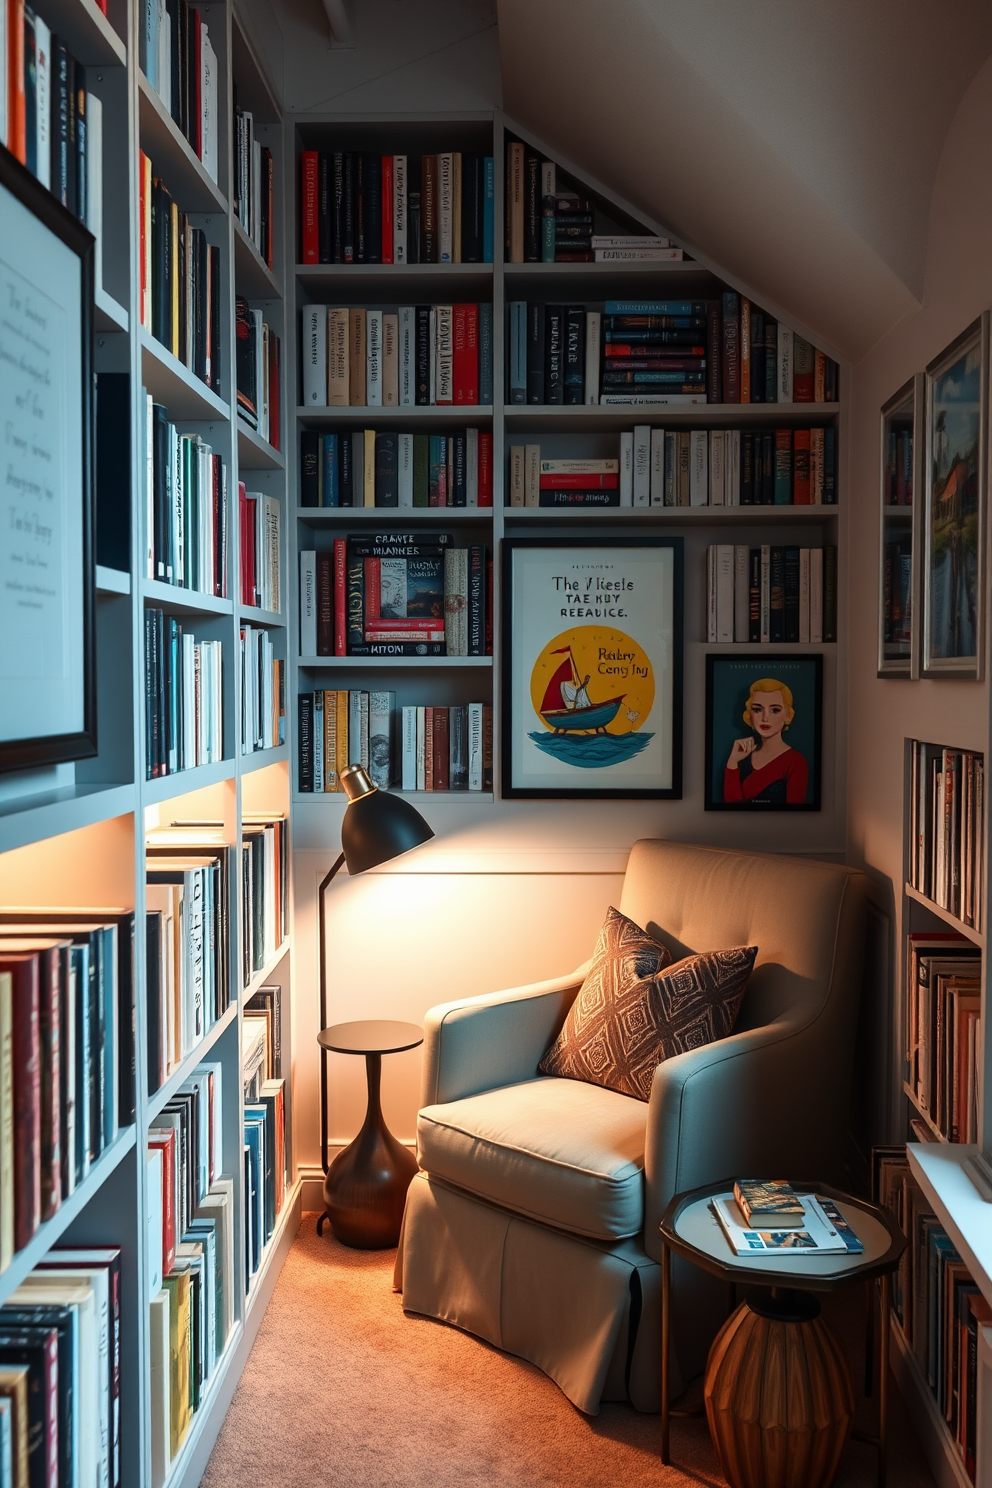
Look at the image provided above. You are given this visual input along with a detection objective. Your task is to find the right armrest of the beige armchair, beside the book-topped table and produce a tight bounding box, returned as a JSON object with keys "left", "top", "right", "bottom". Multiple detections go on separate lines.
{"left": 644, "top": 1009, "right": 820, "bottom": 1259}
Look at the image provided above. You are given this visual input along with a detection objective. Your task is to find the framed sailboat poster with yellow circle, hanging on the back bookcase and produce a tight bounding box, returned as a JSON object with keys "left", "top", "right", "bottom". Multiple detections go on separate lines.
{"left": 503, "top": 537, "right": 683, "bottom": 799}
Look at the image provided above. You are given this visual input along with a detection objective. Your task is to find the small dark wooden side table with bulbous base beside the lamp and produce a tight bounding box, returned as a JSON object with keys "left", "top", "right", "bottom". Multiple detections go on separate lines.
{"left": 317, "top": 1018, "right": 424, "bottom": 1250}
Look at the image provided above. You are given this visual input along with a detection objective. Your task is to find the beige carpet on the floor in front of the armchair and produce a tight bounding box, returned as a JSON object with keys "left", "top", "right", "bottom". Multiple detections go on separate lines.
{"left": 204, "top": 1214, "right": 933, "bottom": 1488}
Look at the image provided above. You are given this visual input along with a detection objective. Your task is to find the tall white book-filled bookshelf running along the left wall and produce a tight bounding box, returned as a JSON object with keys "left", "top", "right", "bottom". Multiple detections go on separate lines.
{"left": 0, "top": 0, "right": 300, "bottom": 1488}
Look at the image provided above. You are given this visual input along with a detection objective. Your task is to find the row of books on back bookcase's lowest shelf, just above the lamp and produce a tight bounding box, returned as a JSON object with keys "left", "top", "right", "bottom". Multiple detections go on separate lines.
{"left": 297, "top": 689, "right": 492, "bottom": 793}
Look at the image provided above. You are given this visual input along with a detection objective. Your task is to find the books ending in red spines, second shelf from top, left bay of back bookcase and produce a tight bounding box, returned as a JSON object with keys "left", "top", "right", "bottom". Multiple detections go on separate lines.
{"left": 300, "top": 304, "right": 492, "bottom": 408}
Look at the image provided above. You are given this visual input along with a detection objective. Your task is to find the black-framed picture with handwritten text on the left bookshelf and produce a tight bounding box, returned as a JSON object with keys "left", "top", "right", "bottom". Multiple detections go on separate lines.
{"left": 0, "top": 149, "right": 97, "bottom": 771}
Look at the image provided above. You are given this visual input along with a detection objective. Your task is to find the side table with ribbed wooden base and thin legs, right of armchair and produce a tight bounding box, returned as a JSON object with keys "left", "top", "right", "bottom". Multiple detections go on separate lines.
{"left": 660, "top": 1178, "right": 906, "bottom": 1488}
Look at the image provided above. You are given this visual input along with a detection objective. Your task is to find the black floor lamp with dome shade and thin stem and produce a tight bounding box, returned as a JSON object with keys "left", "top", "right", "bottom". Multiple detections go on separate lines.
{"left": 317, "top": 765, "right": 434, "bottom": 1244}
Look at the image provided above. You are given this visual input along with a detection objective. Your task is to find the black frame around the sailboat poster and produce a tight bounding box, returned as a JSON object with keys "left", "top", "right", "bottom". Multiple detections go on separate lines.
{"left": 500, "top": 536, "right": 684, "bottom": 801}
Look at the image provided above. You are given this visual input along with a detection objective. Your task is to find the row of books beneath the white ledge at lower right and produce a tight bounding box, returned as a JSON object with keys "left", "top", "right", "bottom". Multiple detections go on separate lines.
{"left": 872, "top": 1147, "right": 992, "bottom": 1482}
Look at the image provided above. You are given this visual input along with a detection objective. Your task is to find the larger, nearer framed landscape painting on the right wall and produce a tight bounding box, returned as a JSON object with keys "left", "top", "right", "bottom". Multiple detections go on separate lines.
{"left": 921, "top": 311, "right": 989, "bottom": 680}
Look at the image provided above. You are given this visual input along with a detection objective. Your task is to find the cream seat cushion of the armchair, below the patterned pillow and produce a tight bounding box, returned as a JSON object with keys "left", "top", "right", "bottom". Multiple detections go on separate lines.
{"left": 416, "top": 1077, "right": 647, "bottom": 1240}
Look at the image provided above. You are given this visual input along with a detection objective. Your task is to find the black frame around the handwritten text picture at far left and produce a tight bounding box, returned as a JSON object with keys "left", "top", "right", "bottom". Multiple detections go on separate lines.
{"left": 0, "top": 146, "right": 97, "bottom": 772}
